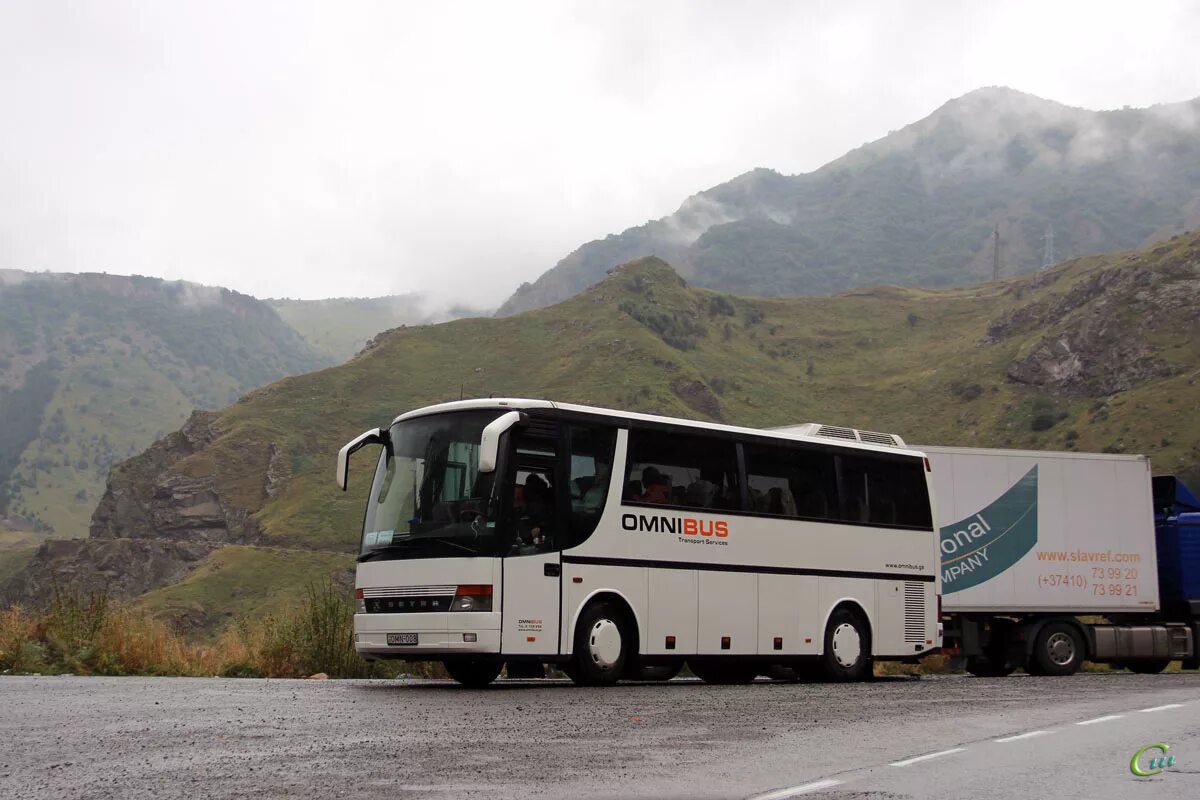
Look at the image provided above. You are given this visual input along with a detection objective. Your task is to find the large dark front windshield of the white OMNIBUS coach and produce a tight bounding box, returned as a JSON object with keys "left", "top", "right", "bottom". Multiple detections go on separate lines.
{"left": 359, "top": 410, "right": 503, "bottom": 561}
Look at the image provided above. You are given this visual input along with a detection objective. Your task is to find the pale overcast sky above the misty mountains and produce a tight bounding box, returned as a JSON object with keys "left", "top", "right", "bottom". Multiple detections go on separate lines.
{"left": 0, "top": 0, "right": 1200, "bottom": 306}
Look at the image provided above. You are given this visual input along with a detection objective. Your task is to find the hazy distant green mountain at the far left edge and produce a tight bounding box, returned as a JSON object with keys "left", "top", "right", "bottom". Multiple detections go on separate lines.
{"left": 0, "top": 270, "right": 330, "bottom": 545}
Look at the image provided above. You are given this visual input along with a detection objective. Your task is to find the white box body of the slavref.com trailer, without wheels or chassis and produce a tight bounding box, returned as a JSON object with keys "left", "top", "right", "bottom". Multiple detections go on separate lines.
{"left": 919, "top": 447, "right": 1158, "bottom": 614}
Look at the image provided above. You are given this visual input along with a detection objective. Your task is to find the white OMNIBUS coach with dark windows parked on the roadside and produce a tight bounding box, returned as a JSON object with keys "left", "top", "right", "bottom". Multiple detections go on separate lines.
{"left": 337, "top": 399, "right": 942, "bottom": 686}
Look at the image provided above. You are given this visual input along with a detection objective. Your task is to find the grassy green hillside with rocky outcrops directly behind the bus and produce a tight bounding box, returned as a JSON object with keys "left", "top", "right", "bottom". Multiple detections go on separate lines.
{"left": 8, "top": 235, "right": 1200, "bottom": 630}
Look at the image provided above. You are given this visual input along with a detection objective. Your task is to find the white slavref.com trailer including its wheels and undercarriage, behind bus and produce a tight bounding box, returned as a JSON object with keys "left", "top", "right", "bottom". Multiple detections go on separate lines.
{"left": 913, "top": 445, "right": 1200, "bottom": 675}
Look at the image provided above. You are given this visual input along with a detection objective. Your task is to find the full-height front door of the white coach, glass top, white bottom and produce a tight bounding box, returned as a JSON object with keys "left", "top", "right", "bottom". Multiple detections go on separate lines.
{"left": 500, "top": 420, "right": 564, "bottom": 655}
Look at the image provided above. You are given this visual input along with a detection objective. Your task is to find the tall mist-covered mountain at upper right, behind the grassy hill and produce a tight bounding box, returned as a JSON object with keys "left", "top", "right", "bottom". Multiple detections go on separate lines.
{"left": 499, "top": 88, "right": 1200, "bottom": 315}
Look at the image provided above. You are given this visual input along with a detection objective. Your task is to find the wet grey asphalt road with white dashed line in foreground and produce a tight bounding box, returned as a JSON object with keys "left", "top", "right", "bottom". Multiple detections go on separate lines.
{"left": 0, "top": 673, "right": 1200, "bottom": 800}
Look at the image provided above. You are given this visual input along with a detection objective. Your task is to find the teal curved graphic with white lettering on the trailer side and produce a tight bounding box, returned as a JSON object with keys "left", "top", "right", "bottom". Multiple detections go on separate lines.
{"left": 941, "top": 464, "right": 1038, "bottom": 595}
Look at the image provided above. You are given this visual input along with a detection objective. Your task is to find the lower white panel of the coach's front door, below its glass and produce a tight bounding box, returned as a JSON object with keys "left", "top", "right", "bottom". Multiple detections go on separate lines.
{"left": 500, "top": 552, "right": 563, "bottom": 656}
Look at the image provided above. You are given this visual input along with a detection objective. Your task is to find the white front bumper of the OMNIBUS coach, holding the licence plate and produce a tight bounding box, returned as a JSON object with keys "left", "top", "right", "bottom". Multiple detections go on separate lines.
{"left": 354, "top": 612, "right": 500, "bottom": 661}
